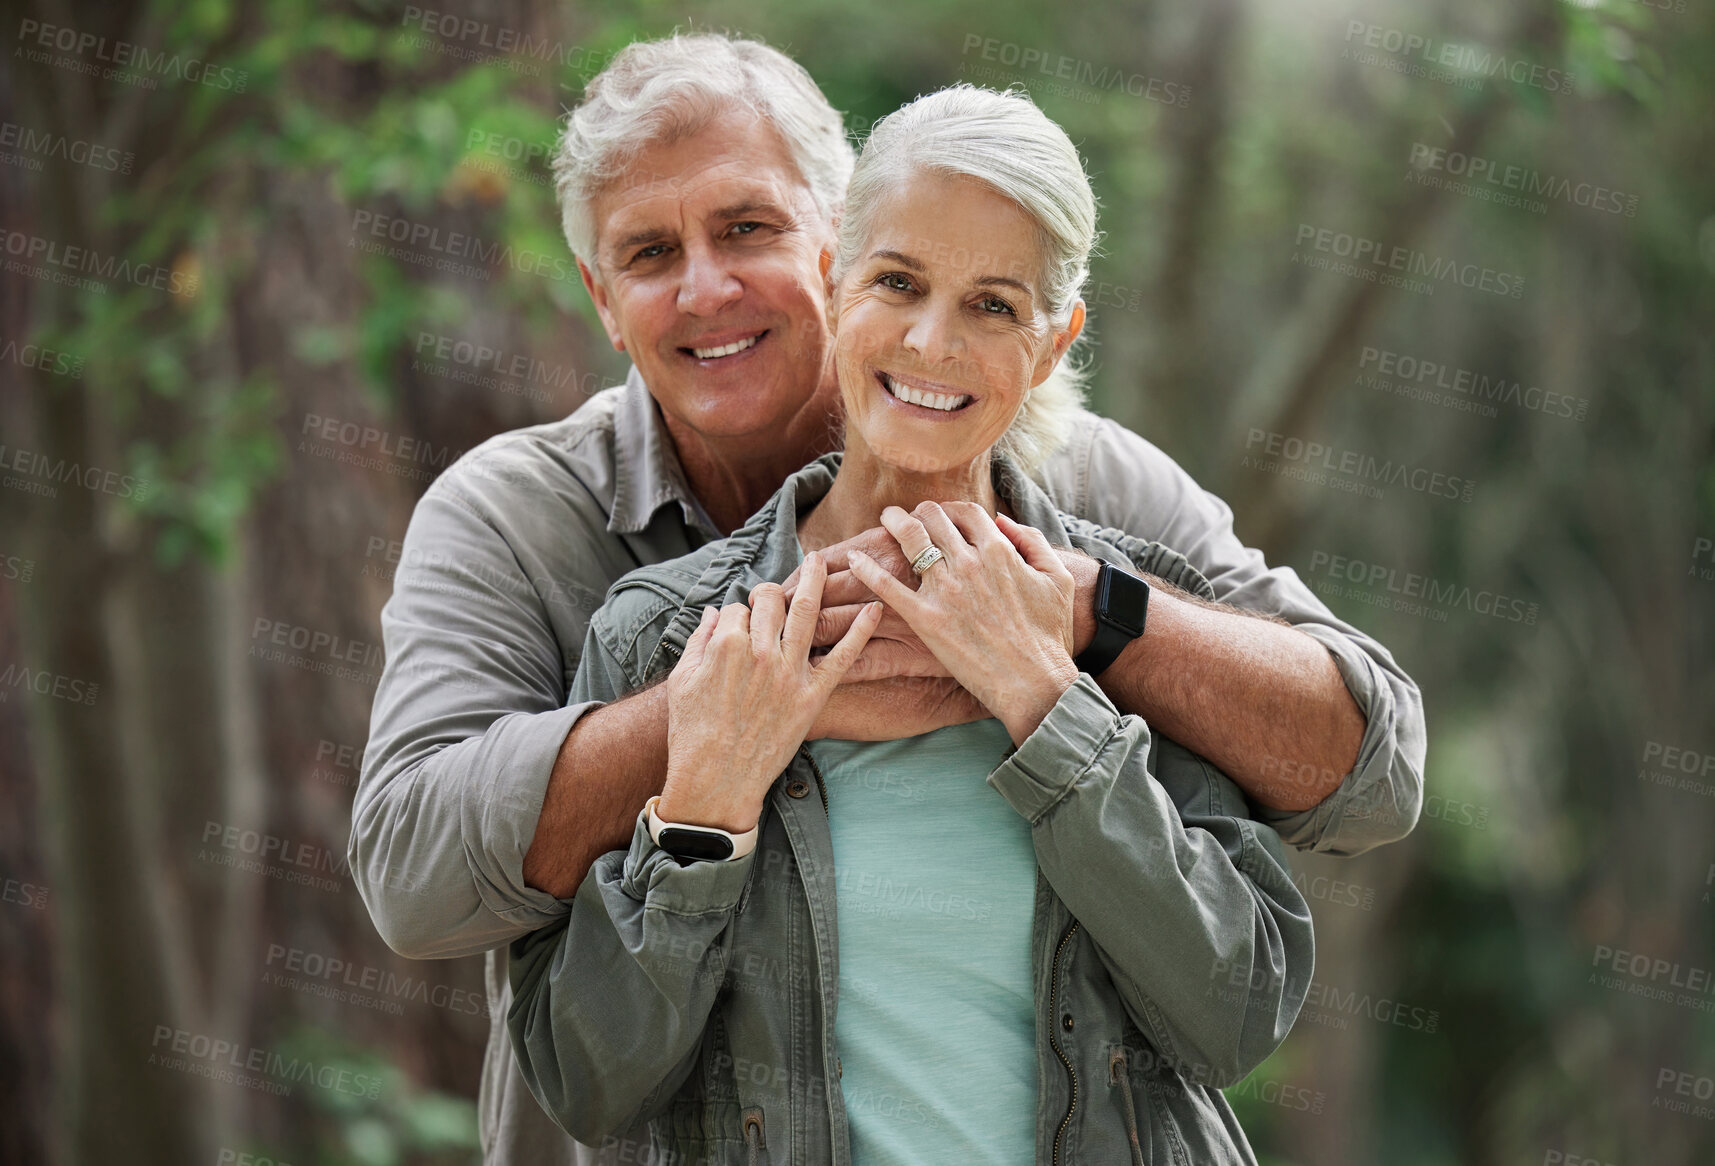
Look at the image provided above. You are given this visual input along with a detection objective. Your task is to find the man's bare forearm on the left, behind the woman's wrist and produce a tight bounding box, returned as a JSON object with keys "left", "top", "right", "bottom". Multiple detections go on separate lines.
{"left": 525, "top": 684, "right": 667, "bottom": 899}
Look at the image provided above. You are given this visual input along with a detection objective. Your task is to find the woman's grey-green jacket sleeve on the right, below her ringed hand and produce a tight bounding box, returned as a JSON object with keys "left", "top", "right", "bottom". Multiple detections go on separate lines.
{"left": 988, "top": 672, "right": 1315, "bottom": 1087}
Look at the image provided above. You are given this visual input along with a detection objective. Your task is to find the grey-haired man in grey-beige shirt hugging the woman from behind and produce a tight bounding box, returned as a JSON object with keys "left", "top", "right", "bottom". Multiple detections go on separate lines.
{"left": 350, "top": 36, "right": 1425, "bottom": 1164}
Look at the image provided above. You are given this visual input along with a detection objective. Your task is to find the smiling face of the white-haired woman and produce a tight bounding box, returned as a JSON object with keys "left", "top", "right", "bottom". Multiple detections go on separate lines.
{"left": 828, "top": 170, "right": 1084, "bottom": 473}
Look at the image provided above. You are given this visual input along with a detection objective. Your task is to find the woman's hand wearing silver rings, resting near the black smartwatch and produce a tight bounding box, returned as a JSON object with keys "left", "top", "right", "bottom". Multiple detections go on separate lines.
{"left": 842, "top": 502, "right": 1077, "bottom": 744}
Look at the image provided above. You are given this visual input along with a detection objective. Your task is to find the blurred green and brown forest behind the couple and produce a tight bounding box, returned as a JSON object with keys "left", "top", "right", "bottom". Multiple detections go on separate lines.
{"left": 0, "top": 0, "right": 1715, "bottom": 1166}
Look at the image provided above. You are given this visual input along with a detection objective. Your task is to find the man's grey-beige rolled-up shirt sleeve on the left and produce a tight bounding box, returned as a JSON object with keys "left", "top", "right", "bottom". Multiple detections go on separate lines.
{"left": 348, "top": 482, "right": 599, "bottom": 959}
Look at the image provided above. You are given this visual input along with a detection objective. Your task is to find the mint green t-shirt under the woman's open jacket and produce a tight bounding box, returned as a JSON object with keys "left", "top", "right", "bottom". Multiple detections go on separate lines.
{"left": 809, "top": 718, "right": 1036, "bottom": 1166}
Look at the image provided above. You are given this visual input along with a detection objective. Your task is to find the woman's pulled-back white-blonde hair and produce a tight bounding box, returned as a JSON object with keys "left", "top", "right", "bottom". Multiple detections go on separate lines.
{"left": 830, "top": 84, "right": 1098, "bottom": 472}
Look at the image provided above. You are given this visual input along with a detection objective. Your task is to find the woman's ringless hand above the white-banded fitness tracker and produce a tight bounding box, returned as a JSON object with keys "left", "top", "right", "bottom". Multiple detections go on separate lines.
{"left": 657, "top": 552, "right": 882, "bottom": 833}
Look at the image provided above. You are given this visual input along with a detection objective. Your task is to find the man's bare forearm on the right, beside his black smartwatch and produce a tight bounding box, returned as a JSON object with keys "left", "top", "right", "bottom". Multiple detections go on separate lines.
{"left": 1068, "top": 559, "right": 1365, "bottom": 811}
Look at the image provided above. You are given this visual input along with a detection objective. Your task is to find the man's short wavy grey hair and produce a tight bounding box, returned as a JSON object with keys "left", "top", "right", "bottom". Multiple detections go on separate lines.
{"left": 552, "top": 33, "right": 852, "bottom": 276}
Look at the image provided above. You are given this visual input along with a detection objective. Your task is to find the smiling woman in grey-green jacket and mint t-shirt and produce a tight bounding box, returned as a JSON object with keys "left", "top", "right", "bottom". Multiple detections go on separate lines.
{"left": 508, "top": 86, "right": 1312, "bottom": 1166}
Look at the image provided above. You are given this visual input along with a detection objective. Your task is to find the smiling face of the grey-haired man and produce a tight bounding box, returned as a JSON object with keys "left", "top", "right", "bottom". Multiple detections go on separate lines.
{"left": 580, "top": 111, "right": 833, "bottom": 439}
